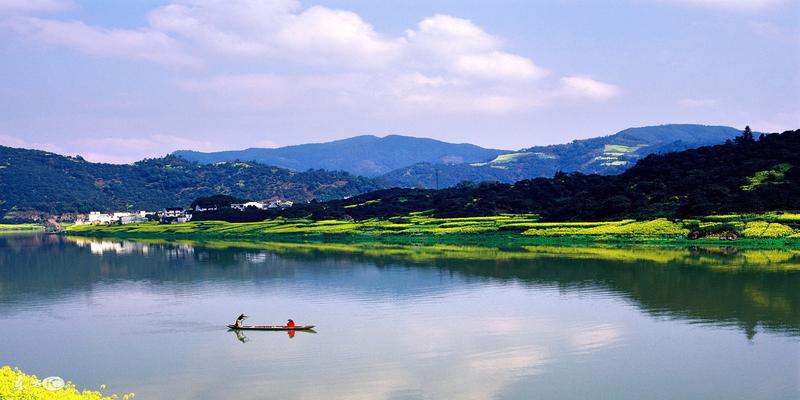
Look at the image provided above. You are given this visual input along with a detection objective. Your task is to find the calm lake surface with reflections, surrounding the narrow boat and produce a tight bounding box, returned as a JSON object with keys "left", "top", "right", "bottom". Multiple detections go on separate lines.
{"left": 0, "top": 236, "right": 800, "bottom": 400}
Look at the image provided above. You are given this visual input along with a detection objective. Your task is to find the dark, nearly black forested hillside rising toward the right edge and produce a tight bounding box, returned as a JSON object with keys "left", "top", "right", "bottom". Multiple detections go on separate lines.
{"left": 264, "top": 130, "right": 800, "bottom": 221}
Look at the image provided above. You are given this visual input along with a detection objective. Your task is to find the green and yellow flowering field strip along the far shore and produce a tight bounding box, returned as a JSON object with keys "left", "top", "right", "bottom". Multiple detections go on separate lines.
{"left": 67, "top": 213, "right": 800, "bottom": 248}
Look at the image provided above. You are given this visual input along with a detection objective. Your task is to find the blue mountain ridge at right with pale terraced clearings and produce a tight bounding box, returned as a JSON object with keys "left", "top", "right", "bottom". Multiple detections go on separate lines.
{"left": 377, "top": 124, "right": 741, "bottom": 188}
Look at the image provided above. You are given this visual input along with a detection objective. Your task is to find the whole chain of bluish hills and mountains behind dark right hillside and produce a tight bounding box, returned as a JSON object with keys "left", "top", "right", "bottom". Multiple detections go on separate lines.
{"left": 0, "top": 125, "right": 752, "bottom": 215}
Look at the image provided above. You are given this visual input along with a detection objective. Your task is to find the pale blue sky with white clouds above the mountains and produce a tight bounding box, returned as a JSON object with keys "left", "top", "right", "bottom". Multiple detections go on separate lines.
{"left": 0, "top": 0, "right": 800, "bottom": 163}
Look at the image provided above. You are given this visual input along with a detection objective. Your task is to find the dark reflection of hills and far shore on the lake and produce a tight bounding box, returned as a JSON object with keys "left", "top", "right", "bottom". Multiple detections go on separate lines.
{"left": 0, "top": 236, "right": 800, "bottom": 338}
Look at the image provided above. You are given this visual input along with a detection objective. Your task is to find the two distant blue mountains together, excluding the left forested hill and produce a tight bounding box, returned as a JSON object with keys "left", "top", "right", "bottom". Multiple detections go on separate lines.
{"left": 173, "top": 124, "right": 740, "bottom": 188}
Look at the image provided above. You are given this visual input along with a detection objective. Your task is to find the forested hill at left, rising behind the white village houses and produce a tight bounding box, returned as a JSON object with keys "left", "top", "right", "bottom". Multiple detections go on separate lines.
{"left": 0, "top": 146, "right": 378, "bottom": 213}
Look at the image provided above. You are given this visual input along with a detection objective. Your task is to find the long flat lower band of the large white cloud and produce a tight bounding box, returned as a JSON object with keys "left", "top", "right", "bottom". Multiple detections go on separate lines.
{"left": 177, "top": 72, "right": 537, "bottom": 116}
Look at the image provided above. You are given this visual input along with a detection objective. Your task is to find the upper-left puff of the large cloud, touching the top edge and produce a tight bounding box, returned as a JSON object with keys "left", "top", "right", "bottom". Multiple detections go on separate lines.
{"left": 148, "top": 0, "right": 397, "bottom": 66}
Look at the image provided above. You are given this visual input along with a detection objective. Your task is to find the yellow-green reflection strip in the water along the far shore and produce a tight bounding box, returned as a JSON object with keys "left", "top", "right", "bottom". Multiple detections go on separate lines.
{"left": 61, "top": 236, "right": 800, "bottom": 272}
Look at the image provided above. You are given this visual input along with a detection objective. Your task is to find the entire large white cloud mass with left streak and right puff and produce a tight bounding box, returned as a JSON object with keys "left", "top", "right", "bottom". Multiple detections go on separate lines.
{"left": 0, "top": 0, "right": 619, "bottom": 120}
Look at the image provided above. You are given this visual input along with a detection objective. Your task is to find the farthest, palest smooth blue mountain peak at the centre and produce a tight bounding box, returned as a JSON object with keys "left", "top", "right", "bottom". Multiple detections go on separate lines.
{"left": 177, "top": 135, "right": 510, "bottom": 177}
